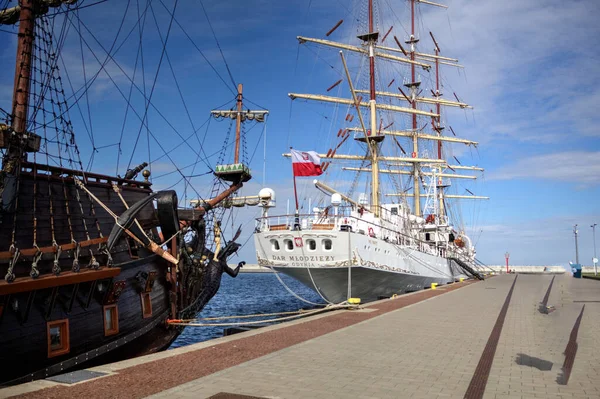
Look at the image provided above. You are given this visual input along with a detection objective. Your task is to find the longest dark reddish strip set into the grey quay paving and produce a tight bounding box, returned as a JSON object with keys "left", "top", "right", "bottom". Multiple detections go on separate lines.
{"left": 464, "top": 275, "right": 519, "bottom": 399}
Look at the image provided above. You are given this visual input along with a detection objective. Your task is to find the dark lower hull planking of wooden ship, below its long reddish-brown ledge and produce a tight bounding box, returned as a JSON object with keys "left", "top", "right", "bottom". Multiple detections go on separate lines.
{"left": 0, "top": 256, "right": 180, "bottom": 385}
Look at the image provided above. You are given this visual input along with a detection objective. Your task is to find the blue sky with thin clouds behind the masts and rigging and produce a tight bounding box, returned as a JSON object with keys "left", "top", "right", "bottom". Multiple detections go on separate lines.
{"left": 0, "top": 0, "right": 600, "bottom": 265}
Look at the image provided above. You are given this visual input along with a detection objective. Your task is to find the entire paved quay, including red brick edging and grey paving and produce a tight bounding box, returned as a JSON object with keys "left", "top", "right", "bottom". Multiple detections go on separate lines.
{"left": 0, "top": 274, "right": 600, "bottom": 399}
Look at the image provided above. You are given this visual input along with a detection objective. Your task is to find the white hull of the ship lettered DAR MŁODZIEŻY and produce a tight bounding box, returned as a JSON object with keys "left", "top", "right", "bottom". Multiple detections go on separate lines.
{"left": 255, "top": 231, "right": 467, "bottom": 303}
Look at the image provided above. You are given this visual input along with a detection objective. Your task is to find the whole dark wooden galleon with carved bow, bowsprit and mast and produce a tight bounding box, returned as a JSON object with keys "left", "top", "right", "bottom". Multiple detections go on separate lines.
{"left": 0, "top": 0, "right": 264, "bottom": 385}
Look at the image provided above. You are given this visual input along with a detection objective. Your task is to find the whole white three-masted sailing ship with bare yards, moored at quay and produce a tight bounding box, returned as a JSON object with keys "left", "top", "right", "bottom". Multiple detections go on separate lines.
{"left": 254, "top": 0, "right": 487, "bottom": 303}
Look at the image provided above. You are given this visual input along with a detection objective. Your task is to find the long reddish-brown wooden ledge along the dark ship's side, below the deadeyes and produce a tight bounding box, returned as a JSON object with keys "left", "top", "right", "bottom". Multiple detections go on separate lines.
{"left": 0, "top": 267, "right": 121, "bottom": 295}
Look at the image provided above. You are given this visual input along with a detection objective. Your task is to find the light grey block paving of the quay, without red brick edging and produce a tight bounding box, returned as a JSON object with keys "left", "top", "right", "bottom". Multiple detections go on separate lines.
{"left": 152, "top": 275, "right": 600, "bottom": 399}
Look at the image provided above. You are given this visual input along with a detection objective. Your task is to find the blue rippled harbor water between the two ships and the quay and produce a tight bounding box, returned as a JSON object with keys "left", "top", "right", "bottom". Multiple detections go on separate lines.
{"left": 169, "top": 273, "right": 324, "bottom": 349}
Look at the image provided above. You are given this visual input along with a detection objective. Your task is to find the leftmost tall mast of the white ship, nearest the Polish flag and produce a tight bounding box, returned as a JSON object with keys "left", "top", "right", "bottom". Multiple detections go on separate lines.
{"left": 367, "top": 0, "right": 379, "bottom": 217}
